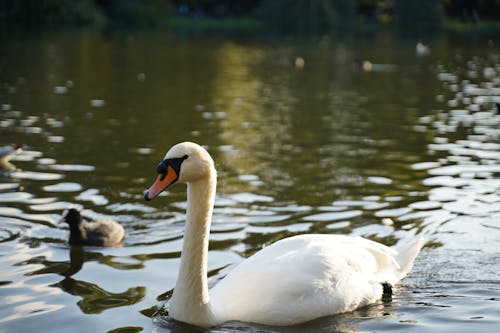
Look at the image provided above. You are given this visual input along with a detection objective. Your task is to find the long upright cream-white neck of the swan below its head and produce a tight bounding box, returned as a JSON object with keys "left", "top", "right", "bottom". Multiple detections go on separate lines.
{"left": 169, "top": 170, "right": 217, "bottom": 326}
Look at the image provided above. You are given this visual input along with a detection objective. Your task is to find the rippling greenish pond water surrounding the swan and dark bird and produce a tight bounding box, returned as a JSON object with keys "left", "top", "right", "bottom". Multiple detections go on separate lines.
{"left": 0, "top": 32, "right": 500, "bottom": 332}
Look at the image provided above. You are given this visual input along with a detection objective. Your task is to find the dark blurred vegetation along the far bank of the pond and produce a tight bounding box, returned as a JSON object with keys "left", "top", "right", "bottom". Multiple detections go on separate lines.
{"left": 0, "top": 0, "right": 500, "bottom": 33}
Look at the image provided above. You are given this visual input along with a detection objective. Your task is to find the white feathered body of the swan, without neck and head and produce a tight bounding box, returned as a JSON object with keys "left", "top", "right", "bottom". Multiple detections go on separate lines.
{"left": 210, "top": 235, "right": 423, "bottom": 325}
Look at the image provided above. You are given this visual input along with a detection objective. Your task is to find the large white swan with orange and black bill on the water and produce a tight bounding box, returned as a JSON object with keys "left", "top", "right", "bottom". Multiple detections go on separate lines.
{"left": 145, "top": 142, "right": 423, "bottom": 326}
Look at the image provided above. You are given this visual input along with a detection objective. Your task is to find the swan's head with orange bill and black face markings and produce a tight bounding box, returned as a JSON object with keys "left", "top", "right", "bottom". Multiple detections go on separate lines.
{"left": 144, "top": 142, "right": 215, "bottom": 201}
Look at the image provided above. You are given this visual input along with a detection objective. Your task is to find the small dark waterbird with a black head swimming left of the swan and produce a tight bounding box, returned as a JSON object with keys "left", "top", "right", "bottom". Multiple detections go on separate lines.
{"left": 61, "top": 208, "right": 125, "bottom": 246}
